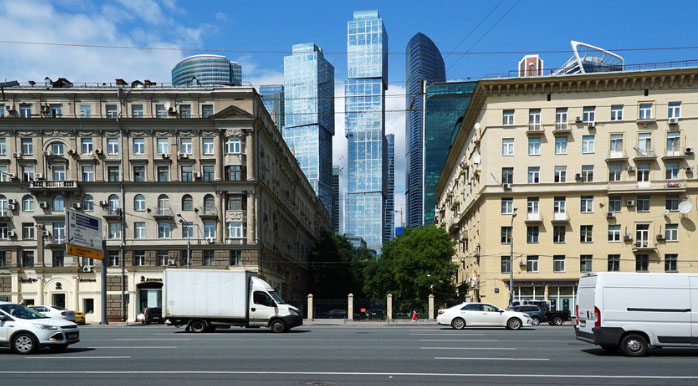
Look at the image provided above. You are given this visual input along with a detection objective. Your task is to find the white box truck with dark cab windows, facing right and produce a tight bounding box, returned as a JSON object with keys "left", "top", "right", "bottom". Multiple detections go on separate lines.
{"left": 163, "top": 269, "right": 303, "bottom": 333}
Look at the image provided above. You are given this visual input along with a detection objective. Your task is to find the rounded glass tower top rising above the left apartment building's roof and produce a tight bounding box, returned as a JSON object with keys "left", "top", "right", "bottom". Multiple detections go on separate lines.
{"left": 172, "top": 55, "right": 242, "bottom": 86}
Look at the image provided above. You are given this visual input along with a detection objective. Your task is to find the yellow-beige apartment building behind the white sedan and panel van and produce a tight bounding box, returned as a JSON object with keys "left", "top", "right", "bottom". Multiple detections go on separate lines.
{"left": 436, "top": 68, "right": 698, "bottom": 311}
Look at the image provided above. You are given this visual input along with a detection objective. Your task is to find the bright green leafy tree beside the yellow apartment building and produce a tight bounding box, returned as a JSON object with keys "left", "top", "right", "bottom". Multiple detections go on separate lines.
{"left": 363, "top": 225, "right": 458, "bottom": 309}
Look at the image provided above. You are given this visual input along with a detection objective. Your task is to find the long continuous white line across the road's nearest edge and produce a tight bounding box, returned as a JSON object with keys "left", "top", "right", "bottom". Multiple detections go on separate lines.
{"left": 3, "top": 370, "right": 698, "bottom": 380}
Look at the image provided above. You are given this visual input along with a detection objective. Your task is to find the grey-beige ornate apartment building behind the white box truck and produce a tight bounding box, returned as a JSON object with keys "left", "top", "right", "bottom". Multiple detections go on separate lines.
{"left": 0, "top": 81, "right": 331, "bottom": 322}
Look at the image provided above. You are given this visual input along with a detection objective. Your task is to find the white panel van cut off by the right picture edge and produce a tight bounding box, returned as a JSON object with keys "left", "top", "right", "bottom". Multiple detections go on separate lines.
{"left": 575, "top": 272, "right": 698, "bottom": 356}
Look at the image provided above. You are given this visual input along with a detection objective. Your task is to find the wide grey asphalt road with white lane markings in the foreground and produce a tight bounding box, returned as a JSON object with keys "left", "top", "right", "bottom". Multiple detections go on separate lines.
{"left": 0, "top": 325, "right": 698, "bottom": 385}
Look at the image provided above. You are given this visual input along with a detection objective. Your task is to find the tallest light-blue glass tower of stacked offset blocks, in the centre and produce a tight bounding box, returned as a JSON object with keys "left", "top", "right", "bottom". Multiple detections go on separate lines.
{"left": 344, "top": 11, "right": 388, "bottom": 250}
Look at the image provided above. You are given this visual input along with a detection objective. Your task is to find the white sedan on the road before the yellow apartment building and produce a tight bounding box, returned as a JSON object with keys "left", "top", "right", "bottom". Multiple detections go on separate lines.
{"left": 436, "top": 303, "right": 533, "bottom": 330}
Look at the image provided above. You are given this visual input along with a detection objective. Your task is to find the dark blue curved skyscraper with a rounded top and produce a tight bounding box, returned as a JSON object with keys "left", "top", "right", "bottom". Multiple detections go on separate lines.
{"left": 405, "top": 32, "right": 446, "bottom": 227}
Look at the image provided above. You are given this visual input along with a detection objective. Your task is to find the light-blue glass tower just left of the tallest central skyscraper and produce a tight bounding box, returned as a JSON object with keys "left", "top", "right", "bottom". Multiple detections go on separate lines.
{"left": 283, "top": 43, "right": 334, "bottom": 217}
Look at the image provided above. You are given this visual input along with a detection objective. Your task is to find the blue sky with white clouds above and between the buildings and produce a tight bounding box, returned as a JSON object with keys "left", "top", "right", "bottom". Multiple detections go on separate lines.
{"left": 0, "top": 0, "right": 698, "bottom": 229}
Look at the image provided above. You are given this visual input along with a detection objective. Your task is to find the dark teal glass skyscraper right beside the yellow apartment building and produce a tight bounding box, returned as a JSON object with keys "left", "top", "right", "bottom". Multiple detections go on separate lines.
{"left": 424, "top": 82, "right": 477, "bottom": 225}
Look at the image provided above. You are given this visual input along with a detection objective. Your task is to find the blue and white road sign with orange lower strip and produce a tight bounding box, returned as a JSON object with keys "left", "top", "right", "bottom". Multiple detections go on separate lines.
{"left": 65, "top": 209, "right": 103, "bottom": 260}
